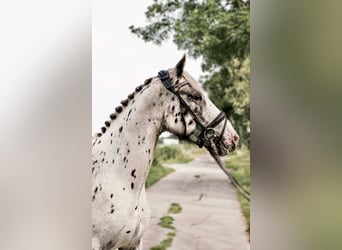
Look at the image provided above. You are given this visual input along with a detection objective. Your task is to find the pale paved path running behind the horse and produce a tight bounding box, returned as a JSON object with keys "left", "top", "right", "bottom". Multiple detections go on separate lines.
{"left": 143, "top": 154, "right": 250, "bottom": 250}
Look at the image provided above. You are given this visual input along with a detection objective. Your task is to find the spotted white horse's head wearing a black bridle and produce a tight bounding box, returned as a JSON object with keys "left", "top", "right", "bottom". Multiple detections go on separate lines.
{"left": 159, "top": 55, "right": 239, "bottom": 156}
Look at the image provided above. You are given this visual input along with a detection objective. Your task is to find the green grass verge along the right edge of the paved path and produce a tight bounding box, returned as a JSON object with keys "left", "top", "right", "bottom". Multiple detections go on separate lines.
{"left": 225, "top": 148, "right": 250, "bottom": 233}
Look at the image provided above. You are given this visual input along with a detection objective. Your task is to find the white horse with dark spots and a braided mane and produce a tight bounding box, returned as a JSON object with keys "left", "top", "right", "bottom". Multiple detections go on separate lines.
{"left": 91, "top": 55, "right": 239, "bottom": 250}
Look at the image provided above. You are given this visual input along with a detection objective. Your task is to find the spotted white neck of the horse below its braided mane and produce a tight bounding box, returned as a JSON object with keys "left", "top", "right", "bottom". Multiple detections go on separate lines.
{"left": 95, "top": 83, "right": 164, "bottom": 195}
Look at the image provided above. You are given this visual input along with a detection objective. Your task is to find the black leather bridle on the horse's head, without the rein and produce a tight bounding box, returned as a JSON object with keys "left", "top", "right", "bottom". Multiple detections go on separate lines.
{"left": 158, "top": 70, "right": 227, "bottom": 149}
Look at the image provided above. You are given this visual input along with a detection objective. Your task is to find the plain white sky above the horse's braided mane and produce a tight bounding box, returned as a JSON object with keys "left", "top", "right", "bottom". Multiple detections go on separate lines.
{"left": 92, "top": 0, "right": 202, "bottom": 134}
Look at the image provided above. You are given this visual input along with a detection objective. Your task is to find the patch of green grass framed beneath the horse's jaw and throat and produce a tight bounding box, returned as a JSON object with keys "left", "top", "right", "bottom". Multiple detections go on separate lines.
{"left": 146, "top": 143, "right": 205, "bottom": 188}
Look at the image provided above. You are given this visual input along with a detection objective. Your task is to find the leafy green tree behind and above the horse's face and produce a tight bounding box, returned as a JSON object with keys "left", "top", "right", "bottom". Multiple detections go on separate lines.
{"left": 129, "top": 0, "right": 250, "bottom": 146}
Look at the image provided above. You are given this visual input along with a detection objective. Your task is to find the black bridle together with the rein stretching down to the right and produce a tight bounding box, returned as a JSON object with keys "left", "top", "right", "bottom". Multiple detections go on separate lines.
{"left": 158, "top": 70, "right": 250, "bottom": 201}
